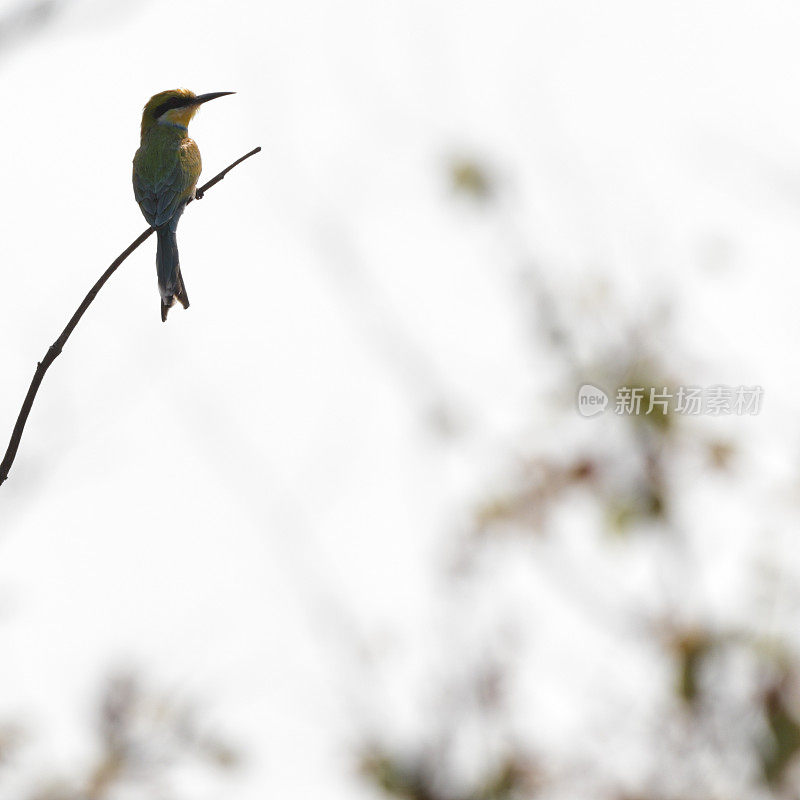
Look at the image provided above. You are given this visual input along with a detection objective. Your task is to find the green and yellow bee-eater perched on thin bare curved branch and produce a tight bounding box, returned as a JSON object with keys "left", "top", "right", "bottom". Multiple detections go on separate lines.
{"left": 133, "top": 89, "right": 234, "bottom": 322}
